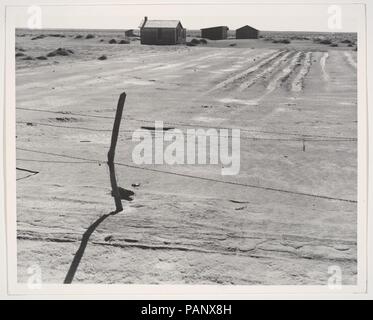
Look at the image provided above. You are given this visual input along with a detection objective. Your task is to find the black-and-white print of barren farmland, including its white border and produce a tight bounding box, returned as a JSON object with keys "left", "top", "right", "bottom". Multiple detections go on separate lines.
{"left": 0, "top": 2, "right": 367, "bottom": 298}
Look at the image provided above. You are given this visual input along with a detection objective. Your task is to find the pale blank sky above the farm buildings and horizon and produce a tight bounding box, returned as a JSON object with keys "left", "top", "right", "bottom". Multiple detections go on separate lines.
{"left": 7, "top": 4, "right": 363, "bottom": 32}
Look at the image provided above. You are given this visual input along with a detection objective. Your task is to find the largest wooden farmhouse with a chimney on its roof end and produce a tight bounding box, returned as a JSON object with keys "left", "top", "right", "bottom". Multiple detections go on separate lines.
{"left": 140, "top": 17, "right": 186, "bottom": 45}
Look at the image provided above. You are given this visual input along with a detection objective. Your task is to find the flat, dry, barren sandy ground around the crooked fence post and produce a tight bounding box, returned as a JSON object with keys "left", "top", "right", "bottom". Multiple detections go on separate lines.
{"left": 16, "top": 32, "right": 357, "bottom": 285}
